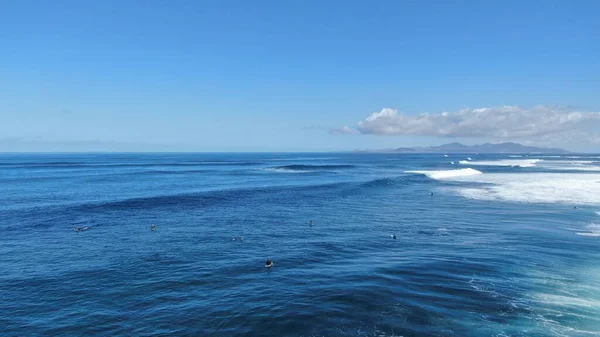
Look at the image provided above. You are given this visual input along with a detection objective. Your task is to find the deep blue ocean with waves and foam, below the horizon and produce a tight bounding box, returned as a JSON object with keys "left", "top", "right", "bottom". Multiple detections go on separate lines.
{"left": 0, "top": 153, "right": 600, "bottom": 336}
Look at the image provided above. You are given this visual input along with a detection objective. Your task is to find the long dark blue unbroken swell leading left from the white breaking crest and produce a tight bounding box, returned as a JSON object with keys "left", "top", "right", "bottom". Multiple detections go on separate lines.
{"left": 0, "top": 175, "right": 432, "bottom": 231}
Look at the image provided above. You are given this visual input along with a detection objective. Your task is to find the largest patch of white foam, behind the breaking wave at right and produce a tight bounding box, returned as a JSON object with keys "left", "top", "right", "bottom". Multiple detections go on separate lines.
{"left": 432, "top": 173, "right": 600, "bottom": 205}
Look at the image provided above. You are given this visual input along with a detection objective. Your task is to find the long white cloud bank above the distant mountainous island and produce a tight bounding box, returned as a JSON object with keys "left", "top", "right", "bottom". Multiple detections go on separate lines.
{"left": 357, "top": 106, "right": 600, "bottom": 143}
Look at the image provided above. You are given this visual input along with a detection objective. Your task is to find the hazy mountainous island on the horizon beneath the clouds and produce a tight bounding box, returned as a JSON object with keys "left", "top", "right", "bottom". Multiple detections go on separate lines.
{"left": 353, "top": 142, "right": 569, "bottom": 154}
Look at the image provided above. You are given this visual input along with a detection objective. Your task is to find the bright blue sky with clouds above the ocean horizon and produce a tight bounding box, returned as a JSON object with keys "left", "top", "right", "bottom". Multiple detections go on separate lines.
{"left": 0, "top": 0, "right": 600, "bottom": 151}
